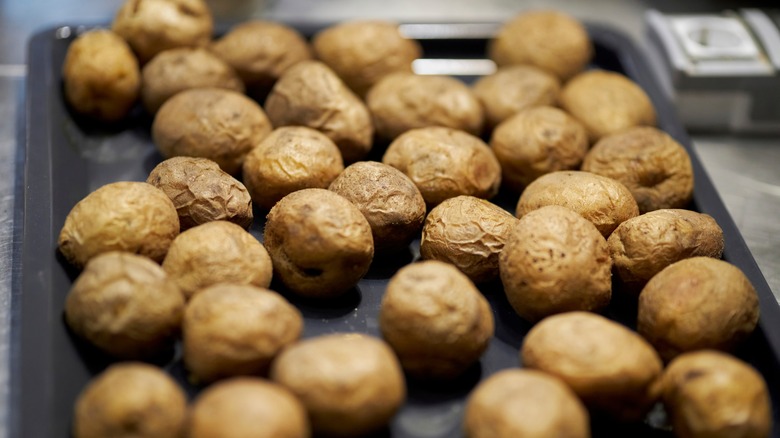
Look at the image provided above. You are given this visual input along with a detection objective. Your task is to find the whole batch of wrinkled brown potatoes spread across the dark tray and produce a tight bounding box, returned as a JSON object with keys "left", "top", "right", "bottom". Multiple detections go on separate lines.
{"left": 58, "top": 0, "right": 772, "bottom": 438}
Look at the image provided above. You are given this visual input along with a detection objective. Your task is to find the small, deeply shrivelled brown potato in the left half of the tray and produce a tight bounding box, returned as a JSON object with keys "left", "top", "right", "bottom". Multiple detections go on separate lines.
{"left": 146, "top": 157, "right": 253, "bottom": 231}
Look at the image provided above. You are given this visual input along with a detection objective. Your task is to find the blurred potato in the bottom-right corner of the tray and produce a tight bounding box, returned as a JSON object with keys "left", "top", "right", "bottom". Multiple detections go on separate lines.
{"left": 662, "top": 350, "right": 772, "bottom": 438}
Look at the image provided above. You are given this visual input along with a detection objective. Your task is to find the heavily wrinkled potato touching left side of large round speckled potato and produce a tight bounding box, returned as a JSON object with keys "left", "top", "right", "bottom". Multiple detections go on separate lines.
{"left": 420, "top": 196, "right": 518, "bottom": 283}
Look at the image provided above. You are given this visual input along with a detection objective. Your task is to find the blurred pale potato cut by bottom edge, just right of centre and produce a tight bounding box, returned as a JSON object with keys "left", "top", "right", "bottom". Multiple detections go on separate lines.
{"left": 463, "top": 369, "right": 590, "bottom": 438}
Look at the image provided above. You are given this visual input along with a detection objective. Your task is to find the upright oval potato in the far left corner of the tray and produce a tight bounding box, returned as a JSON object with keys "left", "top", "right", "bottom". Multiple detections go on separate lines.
{"left": 62, "top": 29, "right": 141, "bottom": 122}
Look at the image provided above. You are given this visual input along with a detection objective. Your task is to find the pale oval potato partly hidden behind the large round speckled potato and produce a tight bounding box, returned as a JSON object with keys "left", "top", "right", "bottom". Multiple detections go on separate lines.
{"left": 516, "top": 171, "right": 639, "bottom": 238}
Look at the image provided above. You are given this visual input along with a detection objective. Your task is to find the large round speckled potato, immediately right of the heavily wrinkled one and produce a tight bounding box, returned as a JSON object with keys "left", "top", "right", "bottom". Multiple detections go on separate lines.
{"left": 498, "top": 205, "right": 612, "bottom": 322}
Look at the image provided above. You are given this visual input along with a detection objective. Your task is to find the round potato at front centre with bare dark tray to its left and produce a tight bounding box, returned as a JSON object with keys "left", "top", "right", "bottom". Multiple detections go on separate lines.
{"left": 379, "top": 260, "right": 494, "bottom": 379}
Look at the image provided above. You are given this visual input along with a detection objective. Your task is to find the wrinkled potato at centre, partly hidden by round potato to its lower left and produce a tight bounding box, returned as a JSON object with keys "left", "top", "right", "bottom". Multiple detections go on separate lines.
{"left": 328, "top": 161, "right": 426, "bottom": 252}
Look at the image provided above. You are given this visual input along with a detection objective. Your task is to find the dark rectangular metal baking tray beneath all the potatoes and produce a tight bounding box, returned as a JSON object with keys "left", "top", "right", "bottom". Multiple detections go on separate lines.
{"left": 10, "top": 23, "right": 780, "bottom": 438}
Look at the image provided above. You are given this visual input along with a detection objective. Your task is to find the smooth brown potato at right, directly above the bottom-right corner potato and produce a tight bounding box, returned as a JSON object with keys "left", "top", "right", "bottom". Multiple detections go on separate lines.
{"left": 637, "top": 257, "right": 759, "bottom": 361}
